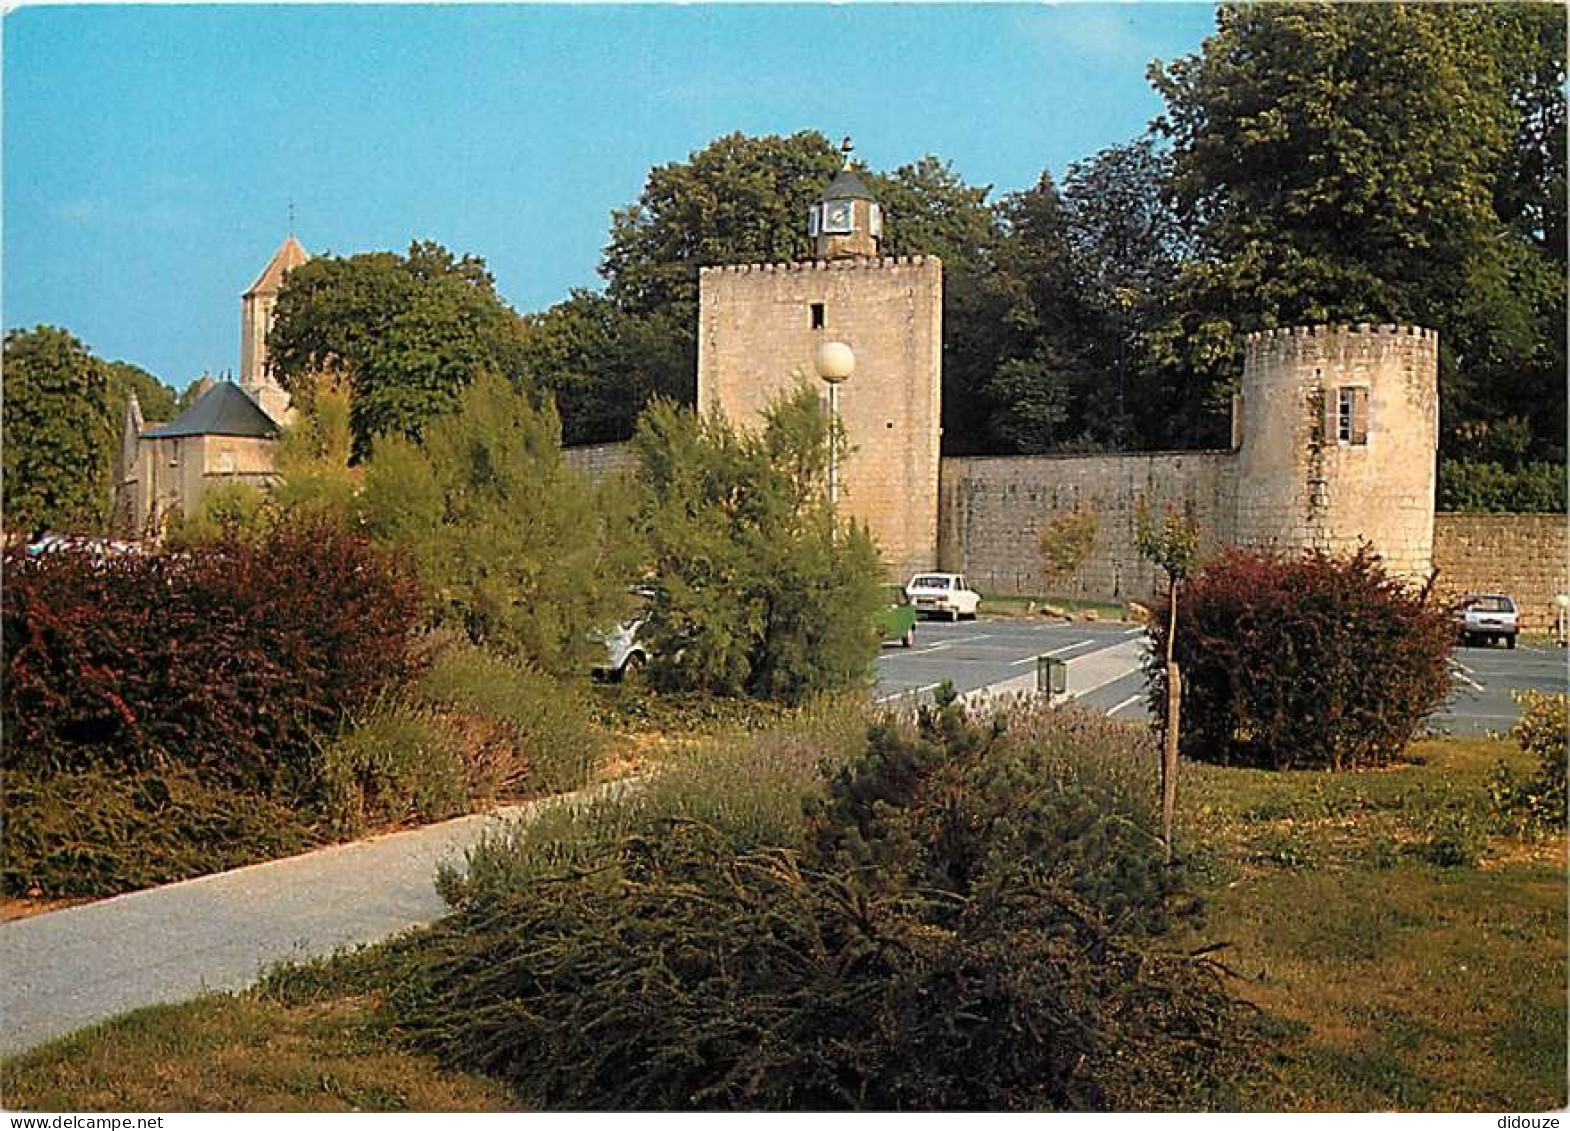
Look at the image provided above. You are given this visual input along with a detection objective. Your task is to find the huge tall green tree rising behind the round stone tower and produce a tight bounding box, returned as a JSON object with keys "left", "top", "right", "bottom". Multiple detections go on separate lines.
{"left": 1145, "top": 3, "right": 1564, "bottom": 446}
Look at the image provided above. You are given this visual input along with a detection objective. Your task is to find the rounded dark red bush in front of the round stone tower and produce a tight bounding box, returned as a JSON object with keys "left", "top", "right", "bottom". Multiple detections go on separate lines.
{"left": 1148, "top": 547, "right": 1455, "bottom": 770}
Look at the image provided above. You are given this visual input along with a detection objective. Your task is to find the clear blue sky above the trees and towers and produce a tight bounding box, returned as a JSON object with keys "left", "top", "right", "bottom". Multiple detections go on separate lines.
{"left": 0, "top": 3, "right": 1214, "bottom": 388}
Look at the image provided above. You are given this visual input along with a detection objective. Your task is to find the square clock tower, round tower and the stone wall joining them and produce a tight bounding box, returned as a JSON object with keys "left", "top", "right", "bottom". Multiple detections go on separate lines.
{"left": 687, "top": 168, "right": 1438, "bottom": 598}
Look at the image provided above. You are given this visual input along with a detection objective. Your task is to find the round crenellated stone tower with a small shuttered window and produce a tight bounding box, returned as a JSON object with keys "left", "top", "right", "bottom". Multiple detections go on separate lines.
{"left": 1237, "top": 324, "right": 1440, "bottom": 580}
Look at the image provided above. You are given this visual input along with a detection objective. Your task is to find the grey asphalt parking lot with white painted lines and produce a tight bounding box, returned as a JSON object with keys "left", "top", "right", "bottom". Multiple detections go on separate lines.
{"left": 878, "top": 616, "right": 1570, "bottom": 737}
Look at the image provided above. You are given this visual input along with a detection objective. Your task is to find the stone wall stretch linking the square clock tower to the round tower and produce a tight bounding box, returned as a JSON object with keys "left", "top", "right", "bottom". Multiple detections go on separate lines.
{"left": 939, "top": 452, "right": 1237, "bottom": 600}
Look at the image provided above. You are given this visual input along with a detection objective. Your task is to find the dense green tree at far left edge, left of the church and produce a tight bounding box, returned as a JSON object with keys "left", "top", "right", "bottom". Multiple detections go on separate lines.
{"left": 3, "top": 325, "right": 108, "bottom": 534}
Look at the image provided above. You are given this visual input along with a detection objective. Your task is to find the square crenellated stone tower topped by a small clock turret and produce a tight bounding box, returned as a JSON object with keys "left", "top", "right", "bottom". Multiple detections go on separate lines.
{"left": 697, "top": 162, "right": 944, "bottom": 578}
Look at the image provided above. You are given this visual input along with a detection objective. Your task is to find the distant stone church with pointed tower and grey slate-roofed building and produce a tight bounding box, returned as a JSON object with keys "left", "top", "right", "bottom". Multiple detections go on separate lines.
{"left": 111, "top": 236, "right": 309, "bottom": 540}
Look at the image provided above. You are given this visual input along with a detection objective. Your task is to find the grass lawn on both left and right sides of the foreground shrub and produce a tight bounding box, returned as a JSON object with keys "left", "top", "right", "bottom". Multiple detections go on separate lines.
{"left": 0, "top": 740, "right": 1567, "bottom": 1112}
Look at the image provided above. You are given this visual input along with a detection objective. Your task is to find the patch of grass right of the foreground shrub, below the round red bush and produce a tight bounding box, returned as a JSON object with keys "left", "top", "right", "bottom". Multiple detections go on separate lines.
{"left": 1179, "top": 740, "right": 1567, "bottom": 1111}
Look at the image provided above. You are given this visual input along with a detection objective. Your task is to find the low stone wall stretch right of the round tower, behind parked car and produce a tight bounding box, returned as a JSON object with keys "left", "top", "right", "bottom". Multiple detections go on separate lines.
{"left": 1433, "top": 514, "right": 1570, "bottom": 631}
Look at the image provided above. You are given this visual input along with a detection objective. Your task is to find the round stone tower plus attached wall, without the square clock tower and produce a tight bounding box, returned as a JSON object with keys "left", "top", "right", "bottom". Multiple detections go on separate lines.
{"left": 939, "top": 325, "right": 1438, "bottom": 600}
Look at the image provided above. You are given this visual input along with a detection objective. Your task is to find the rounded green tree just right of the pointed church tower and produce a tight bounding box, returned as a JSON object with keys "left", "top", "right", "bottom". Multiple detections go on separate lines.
{"left": 267, "top": 242, "right": 523, "bottom": 460}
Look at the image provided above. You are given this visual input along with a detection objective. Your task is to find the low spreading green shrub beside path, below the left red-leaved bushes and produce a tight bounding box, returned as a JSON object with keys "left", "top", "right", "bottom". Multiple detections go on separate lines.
{"left": 0, "top": 767, "right": 317, "bottom": 899}
